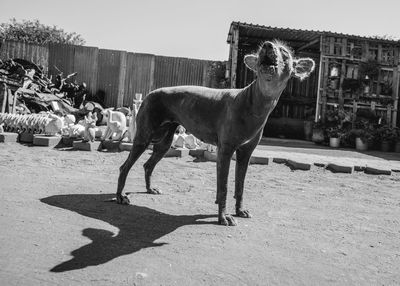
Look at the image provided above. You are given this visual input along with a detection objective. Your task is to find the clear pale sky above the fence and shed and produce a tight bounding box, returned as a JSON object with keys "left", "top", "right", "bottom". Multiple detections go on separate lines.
{"left": 0, "top": 0, "right": 400, "bottom": 60}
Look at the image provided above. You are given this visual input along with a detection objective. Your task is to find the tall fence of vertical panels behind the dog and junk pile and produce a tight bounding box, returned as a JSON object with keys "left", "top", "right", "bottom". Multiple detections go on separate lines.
{"left": 0, "top": 41, "right": 225, "bottom": 107}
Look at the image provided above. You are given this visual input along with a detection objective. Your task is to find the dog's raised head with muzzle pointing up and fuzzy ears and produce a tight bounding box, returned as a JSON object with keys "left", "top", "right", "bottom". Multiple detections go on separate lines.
{"left": 244, "top": 41, "right": 315, "bottom": 89}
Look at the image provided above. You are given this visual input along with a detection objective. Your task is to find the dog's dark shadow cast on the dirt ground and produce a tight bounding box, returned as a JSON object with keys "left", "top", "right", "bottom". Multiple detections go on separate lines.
{"left": 41, "top": 194, "right": 215, "bottom": 272}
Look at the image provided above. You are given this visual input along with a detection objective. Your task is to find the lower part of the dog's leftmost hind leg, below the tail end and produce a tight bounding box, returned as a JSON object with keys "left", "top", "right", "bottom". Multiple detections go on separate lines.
{"left": 117, "top": 141, "right": 149, "bottom": 205}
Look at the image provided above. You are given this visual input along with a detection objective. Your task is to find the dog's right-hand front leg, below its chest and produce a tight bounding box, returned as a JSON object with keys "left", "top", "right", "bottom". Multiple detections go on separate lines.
{"left": 235, "top": 132, "right": 262, "bottom": 218}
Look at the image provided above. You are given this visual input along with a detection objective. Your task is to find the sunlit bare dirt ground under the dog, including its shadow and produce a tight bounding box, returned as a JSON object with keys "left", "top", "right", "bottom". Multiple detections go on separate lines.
{"left": 0, "top": 143, "right": 400, "bottom": 285}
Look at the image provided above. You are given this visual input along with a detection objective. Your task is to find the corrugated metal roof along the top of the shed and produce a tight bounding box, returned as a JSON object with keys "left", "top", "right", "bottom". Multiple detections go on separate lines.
{"left": 227, "top": 22, "right": 400, "bottom": 45}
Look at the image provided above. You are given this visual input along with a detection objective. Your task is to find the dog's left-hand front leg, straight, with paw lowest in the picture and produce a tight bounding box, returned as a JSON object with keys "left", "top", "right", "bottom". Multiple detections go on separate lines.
{"left": 216, "top": 146, "right": 236, "bottom": 226}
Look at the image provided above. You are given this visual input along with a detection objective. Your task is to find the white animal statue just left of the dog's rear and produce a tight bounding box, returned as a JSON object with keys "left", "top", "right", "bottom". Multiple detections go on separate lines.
{"left": 102, "top": 109, "right": 126, "bottom": 140}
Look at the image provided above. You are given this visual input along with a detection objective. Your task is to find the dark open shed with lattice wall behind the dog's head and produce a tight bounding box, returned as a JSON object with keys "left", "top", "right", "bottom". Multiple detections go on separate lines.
{"left": 227, "top": 22, "right": 400, "bottom": 139}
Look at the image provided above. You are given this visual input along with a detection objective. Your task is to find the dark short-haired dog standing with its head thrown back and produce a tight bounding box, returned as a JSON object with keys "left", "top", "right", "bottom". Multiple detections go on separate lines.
{"left": 116, "top": 41, "right": 315, "bottom": 226}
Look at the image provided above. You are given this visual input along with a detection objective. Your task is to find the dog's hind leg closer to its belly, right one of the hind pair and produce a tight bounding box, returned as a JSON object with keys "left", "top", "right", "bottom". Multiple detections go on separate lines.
{"left": 143, "top": 123, "right": 178, "bottom": 194}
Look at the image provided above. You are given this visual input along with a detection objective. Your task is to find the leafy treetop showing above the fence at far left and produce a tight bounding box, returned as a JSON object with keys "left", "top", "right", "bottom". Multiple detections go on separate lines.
{"left": 0, "top": 18, "right": 85, "bottom": 45}
